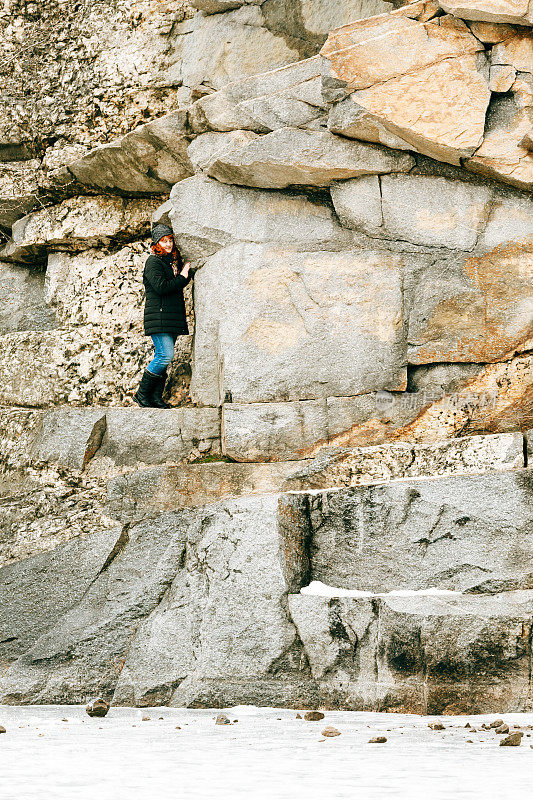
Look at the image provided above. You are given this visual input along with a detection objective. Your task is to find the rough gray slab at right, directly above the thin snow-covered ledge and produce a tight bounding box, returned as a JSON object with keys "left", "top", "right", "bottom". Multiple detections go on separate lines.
{"left": 310, "top": 469, "right": 533, "bottom": 593}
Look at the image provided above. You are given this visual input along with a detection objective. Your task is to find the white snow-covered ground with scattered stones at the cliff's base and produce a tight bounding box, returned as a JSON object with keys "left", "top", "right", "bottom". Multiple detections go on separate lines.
{"left": 0, "top": 706, "right": 533, "bottom": 800}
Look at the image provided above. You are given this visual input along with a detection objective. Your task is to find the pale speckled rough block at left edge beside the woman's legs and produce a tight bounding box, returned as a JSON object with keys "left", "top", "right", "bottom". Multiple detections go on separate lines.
{"left": 0, "top": 325, "right": 151, "bottom": 408}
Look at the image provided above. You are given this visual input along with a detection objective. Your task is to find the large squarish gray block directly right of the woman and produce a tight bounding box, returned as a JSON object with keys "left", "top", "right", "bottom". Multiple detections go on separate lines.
{"left": 191, "top": 244, "right": 406, "bottom": 405}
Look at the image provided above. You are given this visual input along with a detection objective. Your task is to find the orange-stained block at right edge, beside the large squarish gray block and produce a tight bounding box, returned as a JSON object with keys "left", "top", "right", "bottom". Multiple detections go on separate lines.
{"left": 408, "top": 240, "right": 533, "bottom": 364}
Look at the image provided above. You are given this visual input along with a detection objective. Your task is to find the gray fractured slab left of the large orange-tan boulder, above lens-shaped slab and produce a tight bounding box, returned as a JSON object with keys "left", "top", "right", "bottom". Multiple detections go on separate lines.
{"left": 189, "top": 56, "right": 326, "bottom": 133}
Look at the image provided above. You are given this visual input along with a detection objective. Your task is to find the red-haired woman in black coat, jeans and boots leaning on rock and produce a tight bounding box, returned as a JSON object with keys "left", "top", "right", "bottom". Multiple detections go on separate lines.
{"left": 133, "top": 224, "right": 191, "bottom": 408}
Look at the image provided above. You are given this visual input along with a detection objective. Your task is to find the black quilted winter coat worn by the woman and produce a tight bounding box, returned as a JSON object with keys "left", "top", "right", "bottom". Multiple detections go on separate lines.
{"left": 143, "top": 253, "right": 191, "bottom": 336}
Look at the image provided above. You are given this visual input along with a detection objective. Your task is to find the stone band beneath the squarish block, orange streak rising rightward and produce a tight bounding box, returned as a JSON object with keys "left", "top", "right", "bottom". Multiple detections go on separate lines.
{"left": 223, "top": 356, "right": 533, "bottom": 461}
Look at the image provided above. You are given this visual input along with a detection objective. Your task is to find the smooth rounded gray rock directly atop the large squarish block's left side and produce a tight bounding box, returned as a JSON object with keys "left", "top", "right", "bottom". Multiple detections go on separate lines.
{"left": 169, "top": 175, "right": 350, "bottom": 261}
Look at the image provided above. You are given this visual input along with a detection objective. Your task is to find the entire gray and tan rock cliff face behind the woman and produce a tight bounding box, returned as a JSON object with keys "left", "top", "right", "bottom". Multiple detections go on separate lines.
{"left": 0, "top": 0, "right": 533, "bottom": 713}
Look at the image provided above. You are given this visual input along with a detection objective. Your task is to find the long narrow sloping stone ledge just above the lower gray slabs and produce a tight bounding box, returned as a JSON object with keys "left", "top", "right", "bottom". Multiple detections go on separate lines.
{"left": 108, "top": 433, "right": 524, "bottom": 522}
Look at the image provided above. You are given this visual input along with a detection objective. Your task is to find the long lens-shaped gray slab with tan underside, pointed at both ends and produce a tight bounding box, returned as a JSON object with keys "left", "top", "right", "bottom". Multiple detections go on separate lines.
{"left": 208, "top": 128, "right": 414, "bottom": 189}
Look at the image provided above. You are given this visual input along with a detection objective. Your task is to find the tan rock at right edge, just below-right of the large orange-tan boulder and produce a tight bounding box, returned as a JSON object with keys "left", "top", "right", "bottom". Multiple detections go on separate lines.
{"left": 464, "top": 86, "right": 533, "bottom": 190}
